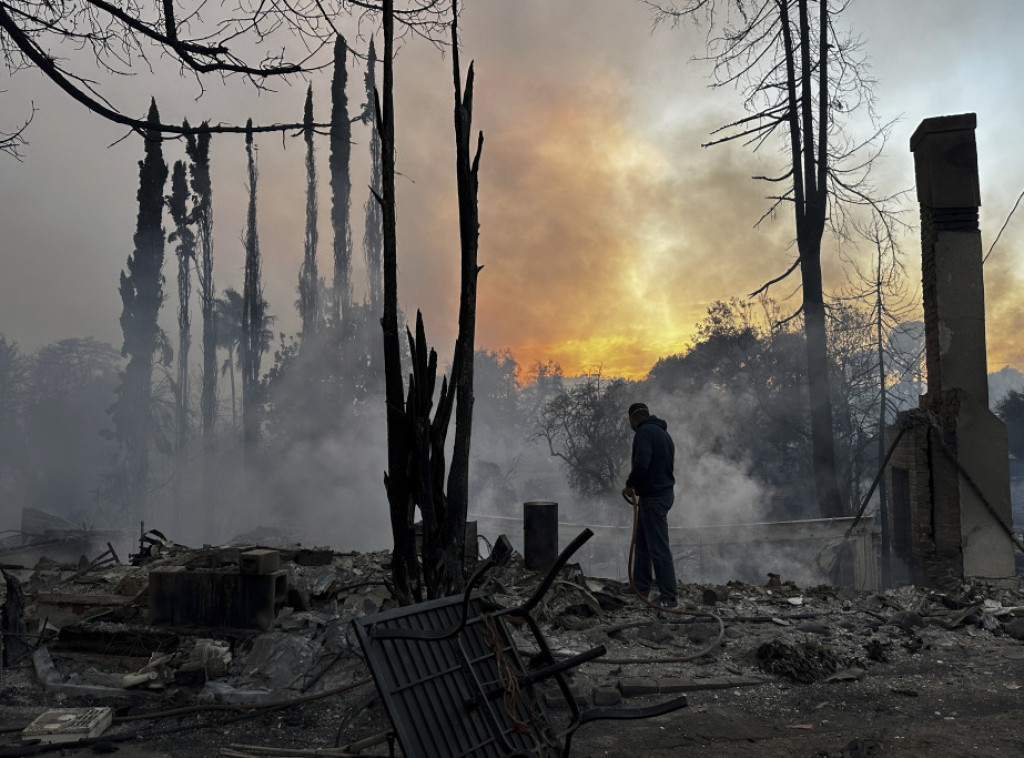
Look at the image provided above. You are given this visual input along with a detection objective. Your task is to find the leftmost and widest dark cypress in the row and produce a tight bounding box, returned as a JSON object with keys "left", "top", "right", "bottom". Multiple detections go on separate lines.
{"left": 112, "top": 100, "right": 169, "bottom": 515}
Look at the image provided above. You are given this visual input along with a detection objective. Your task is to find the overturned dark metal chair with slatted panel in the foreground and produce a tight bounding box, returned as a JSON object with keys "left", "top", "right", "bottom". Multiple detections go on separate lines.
{"left": 353, "top": 529, "right": 686, "bottom": 758}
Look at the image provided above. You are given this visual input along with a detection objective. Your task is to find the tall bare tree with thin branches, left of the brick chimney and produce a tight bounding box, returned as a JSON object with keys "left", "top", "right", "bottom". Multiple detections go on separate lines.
{"left": 643, "top": 0, "right": 886, "bottom": 517}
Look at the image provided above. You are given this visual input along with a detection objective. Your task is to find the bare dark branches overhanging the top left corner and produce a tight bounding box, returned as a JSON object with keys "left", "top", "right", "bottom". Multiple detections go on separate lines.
{"left": 0, "top": 0, "right": 327, "bottom": 137}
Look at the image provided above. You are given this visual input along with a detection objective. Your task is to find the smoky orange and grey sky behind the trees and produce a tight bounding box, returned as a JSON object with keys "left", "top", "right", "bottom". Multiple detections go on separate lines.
{"left": 0, "top": 0, "right": 1024, "bottom": 378}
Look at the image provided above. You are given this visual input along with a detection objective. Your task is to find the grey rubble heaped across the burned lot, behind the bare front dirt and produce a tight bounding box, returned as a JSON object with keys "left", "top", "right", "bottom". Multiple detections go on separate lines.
{"left": 0, "top": 542, "right": 1024, "bottom": 758}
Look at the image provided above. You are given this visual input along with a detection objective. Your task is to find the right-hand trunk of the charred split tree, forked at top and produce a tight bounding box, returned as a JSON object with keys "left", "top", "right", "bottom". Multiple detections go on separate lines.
{"left": 444, "top": 3, "right": 483, "bottom": 592}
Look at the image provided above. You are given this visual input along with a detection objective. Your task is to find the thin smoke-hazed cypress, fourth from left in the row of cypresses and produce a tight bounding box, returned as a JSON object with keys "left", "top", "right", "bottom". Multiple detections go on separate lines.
{"left": 241, "top": 120, "right": 266, "bottom": 466}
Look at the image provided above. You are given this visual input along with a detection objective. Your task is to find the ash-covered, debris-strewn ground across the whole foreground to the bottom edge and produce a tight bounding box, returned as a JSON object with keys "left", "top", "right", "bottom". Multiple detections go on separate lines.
{"left": 0, "top": 546, "right": 1024, "bottom": 758}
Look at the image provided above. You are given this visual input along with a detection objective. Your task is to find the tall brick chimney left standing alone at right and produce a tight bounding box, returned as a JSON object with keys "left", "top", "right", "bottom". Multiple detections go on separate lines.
{"left": 888, "top": 114, "right": 1016, "bottom": 585}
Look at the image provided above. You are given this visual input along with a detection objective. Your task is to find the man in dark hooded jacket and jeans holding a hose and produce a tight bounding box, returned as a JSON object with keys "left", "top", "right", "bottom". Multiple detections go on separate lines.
{"left": 623, "top": 403, "right": 679, "bottom": 608}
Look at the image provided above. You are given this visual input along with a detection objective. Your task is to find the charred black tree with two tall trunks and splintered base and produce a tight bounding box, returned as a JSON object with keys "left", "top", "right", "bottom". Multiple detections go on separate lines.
{"left": 377, "top": 0, "right": 479, "bottom": 603}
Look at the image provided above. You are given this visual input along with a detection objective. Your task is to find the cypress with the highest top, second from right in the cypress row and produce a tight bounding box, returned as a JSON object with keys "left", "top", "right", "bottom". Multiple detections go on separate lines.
{"left": 329, "top": 34, "right": 358, "bottom": 333}
